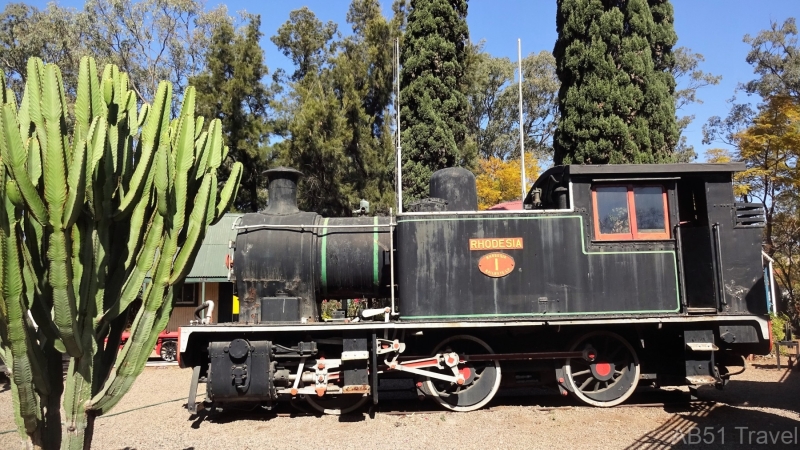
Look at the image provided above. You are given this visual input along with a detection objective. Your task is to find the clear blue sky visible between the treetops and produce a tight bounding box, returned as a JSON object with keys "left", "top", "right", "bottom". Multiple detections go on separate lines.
{"left": 27, "top": 0, "right": 800, "bottom": 159}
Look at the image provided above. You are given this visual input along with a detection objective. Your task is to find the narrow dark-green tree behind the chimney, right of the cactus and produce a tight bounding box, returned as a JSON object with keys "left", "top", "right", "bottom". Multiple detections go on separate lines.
{"left": 190, "top": 15, "right": 271, "bottom": 211}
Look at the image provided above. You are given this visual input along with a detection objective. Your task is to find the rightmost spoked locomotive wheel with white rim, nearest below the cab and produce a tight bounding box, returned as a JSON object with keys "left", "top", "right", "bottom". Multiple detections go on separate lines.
{"left": 564, "top": 331, "right": 640, "bottom": 407}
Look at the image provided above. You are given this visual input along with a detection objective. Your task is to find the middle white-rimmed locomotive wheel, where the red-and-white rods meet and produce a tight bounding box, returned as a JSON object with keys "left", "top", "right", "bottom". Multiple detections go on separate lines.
{"left": 425, "top": 335, "right": 500, "bottom": 412}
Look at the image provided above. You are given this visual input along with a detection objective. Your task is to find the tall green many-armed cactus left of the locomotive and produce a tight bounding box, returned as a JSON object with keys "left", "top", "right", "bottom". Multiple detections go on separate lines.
{"left": 0, "top": 58, "right": 242, "bottom": 449}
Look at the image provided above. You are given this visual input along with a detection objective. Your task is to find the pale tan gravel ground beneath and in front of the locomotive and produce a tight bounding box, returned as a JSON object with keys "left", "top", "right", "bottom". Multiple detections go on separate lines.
{"left": 0, "top": 359, "right": 800, "bottom": 450}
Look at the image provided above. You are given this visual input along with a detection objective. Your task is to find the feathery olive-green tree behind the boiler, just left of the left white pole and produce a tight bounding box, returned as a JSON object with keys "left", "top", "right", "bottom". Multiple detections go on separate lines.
{"left": 273, "top": 0, "right": 399, "bottom": 216}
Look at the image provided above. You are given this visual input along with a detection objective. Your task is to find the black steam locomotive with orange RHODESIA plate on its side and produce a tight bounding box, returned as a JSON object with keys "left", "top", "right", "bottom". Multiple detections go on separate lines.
{"left": 179, "top": 164, "right": 771, "bottom": 413}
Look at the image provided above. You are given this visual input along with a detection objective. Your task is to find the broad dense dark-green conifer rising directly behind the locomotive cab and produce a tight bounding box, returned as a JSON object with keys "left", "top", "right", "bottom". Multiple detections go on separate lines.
{"left": 553, "top": 0, "right": 678, "bottom": 164}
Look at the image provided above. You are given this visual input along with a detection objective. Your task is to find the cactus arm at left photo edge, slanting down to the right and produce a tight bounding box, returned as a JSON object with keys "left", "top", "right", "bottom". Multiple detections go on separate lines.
{"left": 0, "top": 104, "right": 48, "bottom": 224}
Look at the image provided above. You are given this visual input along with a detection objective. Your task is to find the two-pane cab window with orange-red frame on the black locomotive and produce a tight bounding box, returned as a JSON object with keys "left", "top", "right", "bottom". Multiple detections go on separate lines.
{"left": 592, "top": 185, "right": 670, "bottom": 241}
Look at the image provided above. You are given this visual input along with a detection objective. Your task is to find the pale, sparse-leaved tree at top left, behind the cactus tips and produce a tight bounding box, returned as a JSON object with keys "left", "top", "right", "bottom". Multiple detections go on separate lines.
{"left": 0, "top": 0, "right": 230, "bottom": 106}
